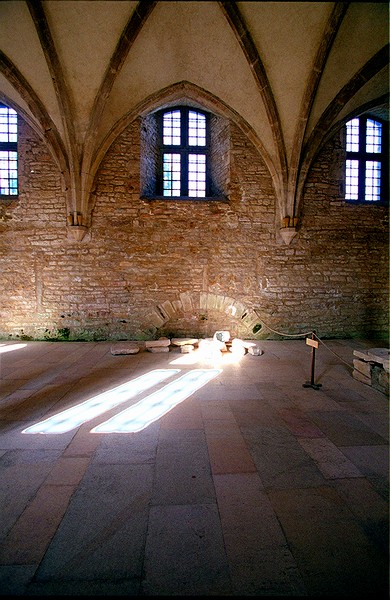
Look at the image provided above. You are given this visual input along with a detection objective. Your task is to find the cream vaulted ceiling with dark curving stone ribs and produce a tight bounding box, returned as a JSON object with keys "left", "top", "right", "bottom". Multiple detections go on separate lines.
{"left": 0, "top": 0, "right": 389, "bottom": 223}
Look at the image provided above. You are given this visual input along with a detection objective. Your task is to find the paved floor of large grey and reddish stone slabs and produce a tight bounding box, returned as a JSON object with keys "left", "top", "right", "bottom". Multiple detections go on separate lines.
{"left": 0, "top": 339, "right": 389, "bottom": 598}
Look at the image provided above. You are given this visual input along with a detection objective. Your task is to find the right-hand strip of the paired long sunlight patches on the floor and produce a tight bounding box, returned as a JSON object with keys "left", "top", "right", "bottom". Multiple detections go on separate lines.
{"left": 91, "top": 369, "right": 222, "bottom": 433}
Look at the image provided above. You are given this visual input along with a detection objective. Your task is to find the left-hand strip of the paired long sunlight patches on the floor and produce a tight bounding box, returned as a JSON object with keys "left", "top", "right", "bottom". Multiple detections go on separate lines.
{"left": 22, "top": 369, "right": 180, "bottom": 433}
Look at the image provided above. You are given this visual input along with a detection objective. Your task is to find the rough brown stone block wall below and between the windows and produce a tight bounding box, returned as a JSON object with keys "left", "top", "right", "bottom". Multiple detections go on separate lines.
{"left": 0, "top": 120, "right": 388, "bottom": 340}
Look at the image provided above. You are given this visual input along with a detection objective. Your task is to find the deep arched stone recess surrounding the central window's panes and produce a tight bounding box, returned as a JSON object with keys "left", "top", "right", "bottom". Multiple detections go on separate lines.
{"left": 140, "top": 101, "right": 230, "bottom": 203}
